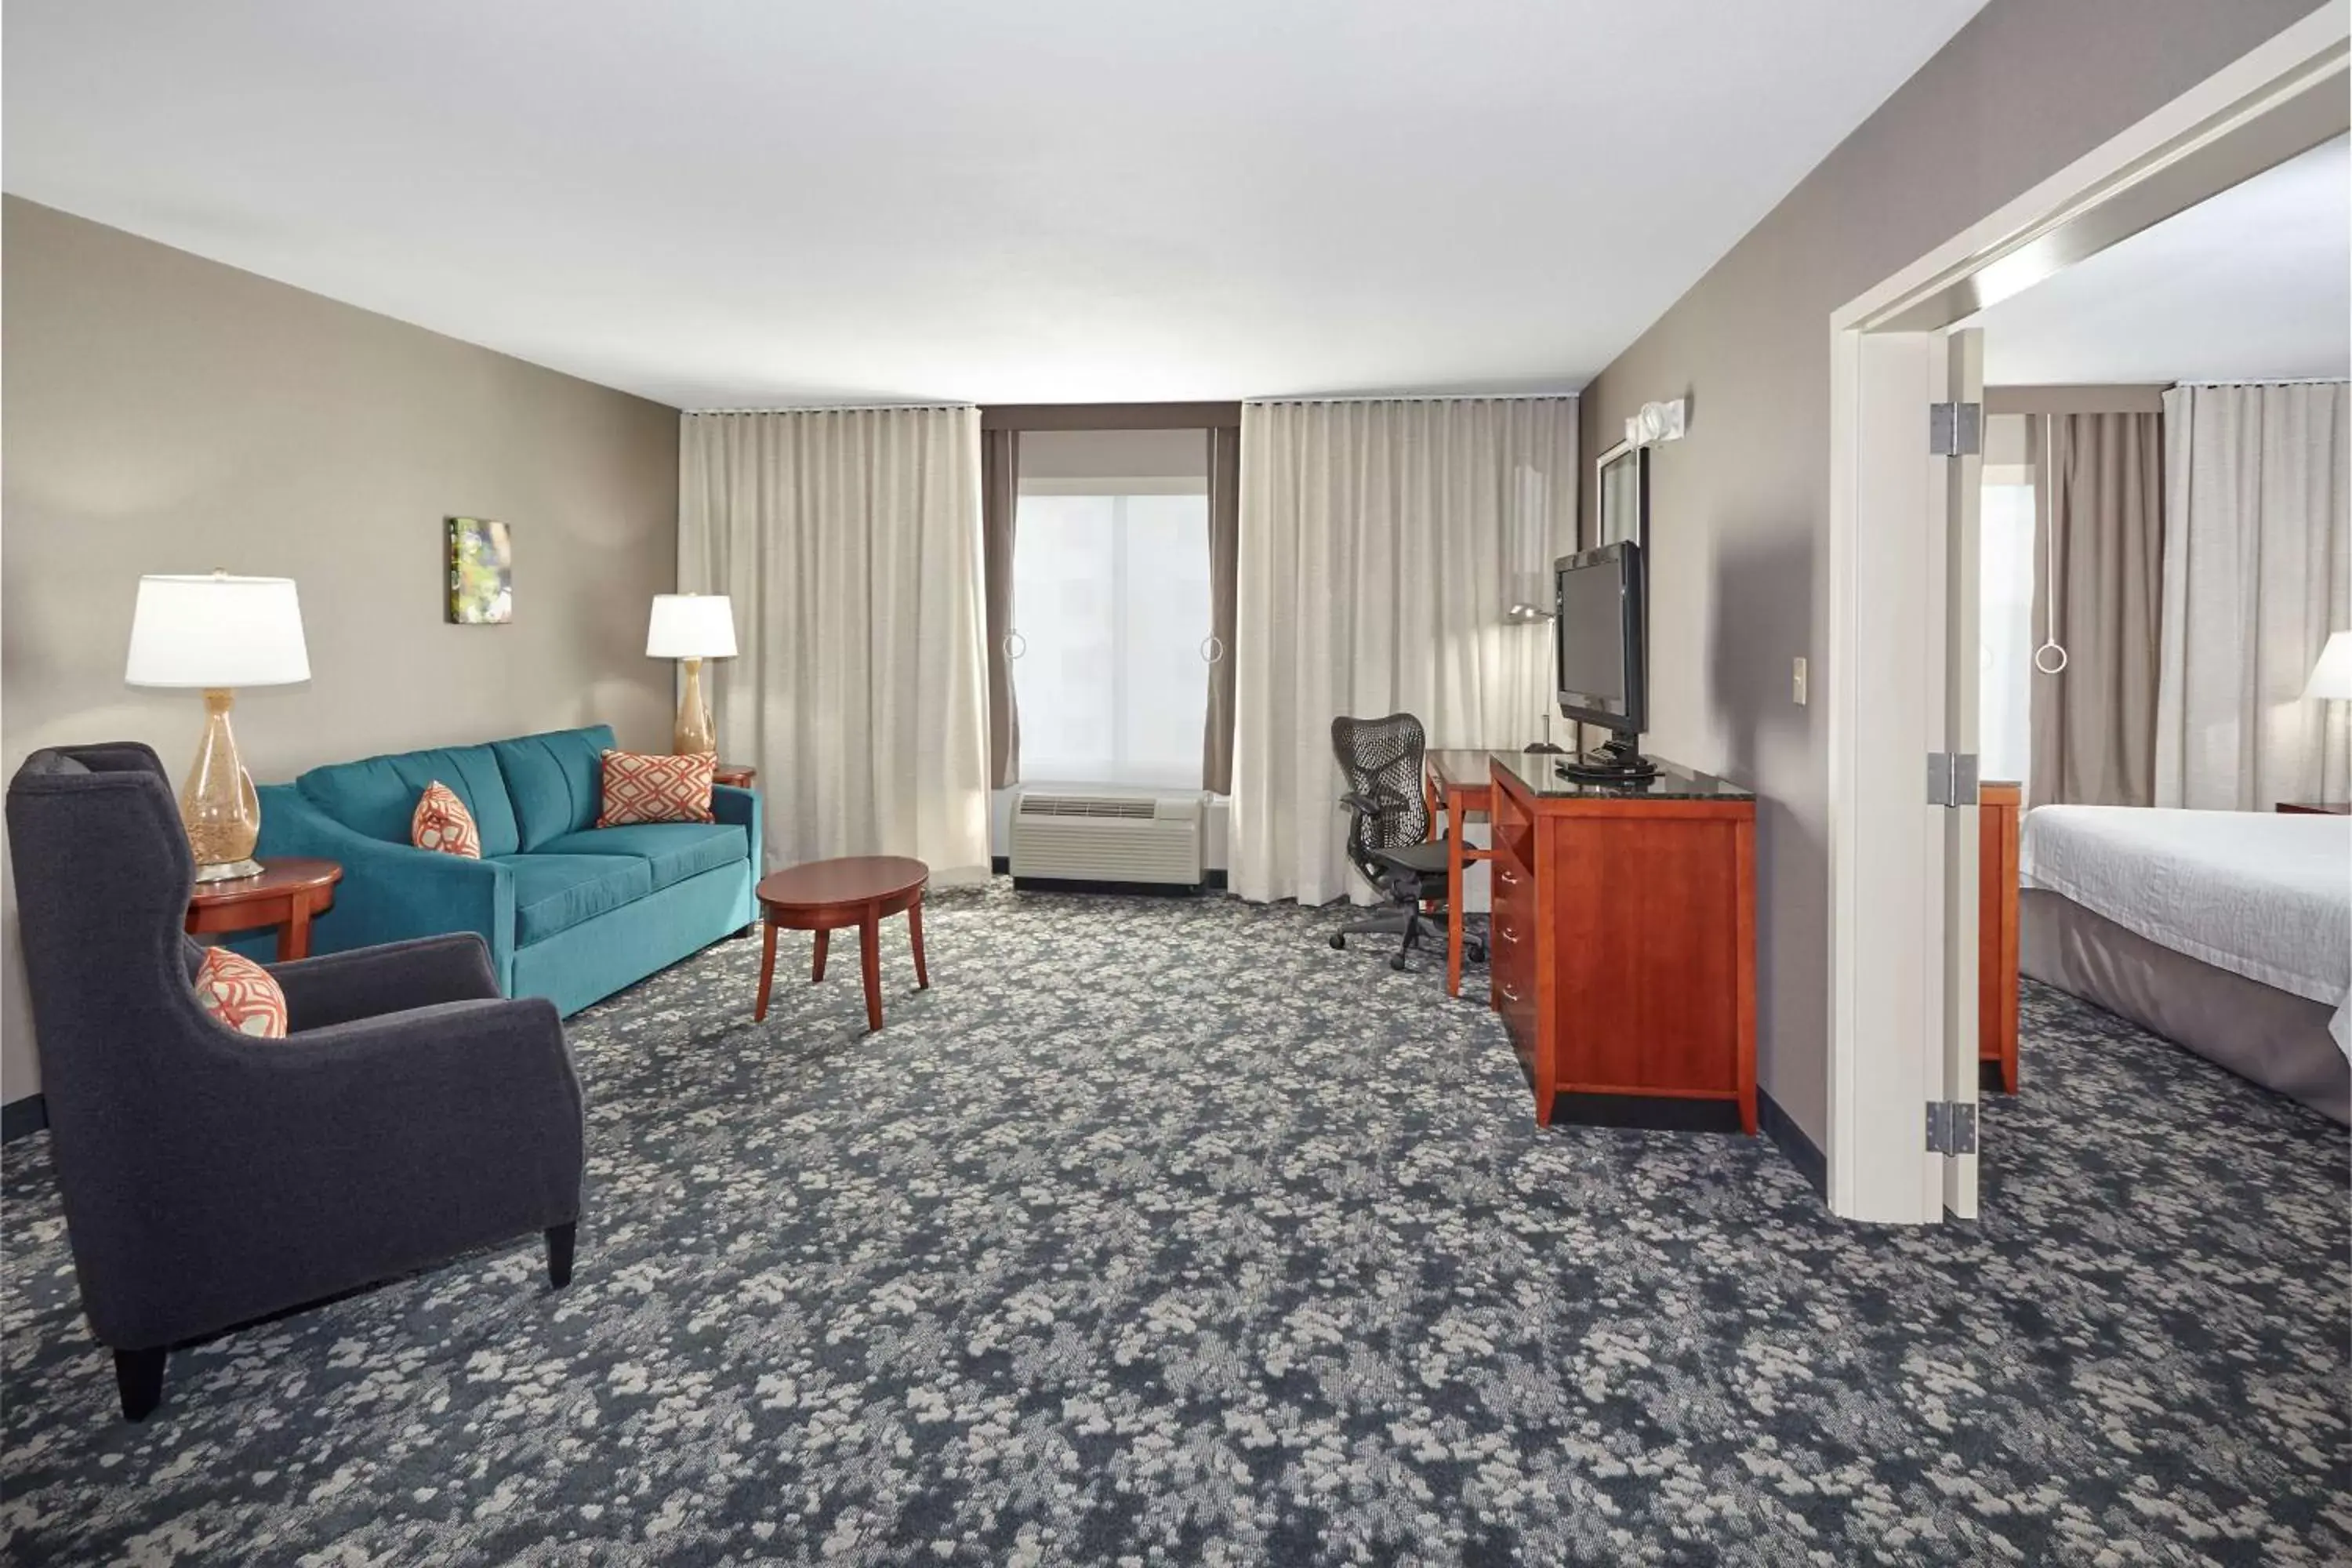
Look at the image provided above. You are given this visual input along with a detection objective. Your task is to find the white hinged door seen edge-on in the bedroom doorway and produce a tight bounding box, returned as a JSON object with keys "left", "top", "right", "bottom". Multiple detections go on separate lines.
{"left": 1926, "top": 327, "right": 1985, "bottom": 1220}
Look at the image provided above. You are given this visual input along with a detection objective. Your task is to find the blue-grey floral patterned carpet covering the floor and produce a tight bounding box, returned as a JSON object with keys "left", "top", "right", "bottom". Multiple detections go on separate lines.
{"left": 0, "top": 886, "right": 2352, "bottom": 1568}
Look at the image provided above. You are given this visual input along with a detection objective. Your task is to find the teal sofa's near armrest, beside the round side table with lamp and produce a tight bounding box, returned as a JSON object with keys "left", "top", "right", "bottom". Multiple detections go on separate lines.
{"left": 256, "top": 785, "right": 515, "bottom": 982}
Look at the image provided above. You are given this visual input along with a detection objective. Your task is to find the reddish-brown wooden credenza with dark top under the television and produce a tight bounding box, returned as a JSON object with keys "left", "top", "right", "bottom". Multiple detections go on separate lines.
{"left": 1489, "top": 753, "right": 1757, "bottom": 1133}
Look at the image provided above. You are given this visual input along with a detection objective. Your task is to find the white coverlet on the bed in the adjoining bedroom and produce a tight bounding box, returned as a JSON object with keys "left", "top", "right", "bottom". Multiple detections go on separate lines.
{"left": 2018, "top": 806, "right": 2352, "bottom": 1058}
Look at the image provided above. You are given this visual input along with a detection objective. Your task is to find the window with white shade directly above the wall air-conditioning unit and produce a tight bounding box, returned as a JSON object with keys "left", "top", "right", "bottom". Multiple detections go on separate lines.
{"left": 1011, "top": 480, "right": 1211, "bottom": 789}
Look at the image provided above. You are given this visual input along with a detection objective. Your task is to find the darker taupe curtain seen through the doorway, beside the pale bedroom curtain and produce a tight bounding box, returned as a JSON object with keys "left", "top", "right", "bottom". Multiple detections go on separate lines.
{"left": 2027, "top": 414, "right": 2164, "bottom": 806}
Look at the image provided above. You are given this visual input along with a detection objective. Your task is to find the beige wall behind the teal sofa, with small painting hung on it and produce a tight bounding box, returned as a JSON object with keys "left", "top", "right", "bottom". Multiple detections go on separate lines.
{"left": 0, "top": 198, "right": 677, "bottom": 1100}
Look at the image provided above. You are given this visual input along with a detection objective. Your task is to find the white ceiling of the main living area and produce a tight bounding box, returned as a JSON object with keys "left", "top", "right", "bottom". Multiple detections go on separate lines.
{"left": 0, "top": 0, "right": 1983, "bottom": 407}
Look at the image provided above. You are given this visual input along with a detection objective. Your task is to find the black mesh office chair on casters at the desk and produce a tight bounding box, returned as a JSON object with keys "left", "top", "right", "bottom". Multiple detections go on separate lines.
{"left": 1331, "top": 713, "right": 1486, "bottom": 968}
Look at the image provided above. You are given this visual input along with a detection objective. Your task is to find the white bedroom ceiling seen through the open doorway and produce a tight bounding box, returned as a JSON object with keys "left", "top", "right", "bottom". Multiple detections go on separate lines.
{"left": 1973, "top": 136, "right": 2352, "bottom": 386}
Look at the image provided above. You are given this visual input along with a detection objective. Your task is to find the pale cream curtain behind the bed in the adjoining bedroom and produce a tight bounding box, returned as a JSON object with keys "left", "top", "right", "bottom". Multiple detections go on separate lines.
{"left": 2157, "top": 381, "right": 2352, "bottom": 811}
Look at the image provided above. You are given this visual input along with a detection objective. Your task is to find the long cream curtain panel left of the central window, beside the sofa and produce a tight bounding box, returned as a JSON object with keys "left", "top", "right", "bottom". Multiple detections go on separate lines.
{"left": 677, "top": 409, "right": 988, "bottom": 884}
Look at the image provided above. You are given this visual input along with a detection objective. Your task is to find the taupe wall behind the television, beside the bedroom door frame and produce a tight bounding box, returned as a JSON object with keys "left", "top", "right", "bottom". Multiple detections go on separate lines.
{"left": 1583, "top": 0, "right": 2317, "bottom": 1142}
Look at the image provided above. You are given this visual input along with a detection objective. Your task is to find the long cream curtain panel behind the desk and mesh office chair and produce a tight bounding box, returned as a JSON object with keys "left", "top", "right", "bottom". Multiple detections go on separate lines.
{"left": 1232, "top": 397, "right": 1576, "bottom": 902}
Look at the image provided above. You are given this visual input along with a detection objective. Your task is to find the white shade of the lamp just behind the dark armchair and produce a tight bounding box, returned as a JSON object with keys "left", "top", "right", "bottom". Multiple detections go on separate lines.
{"left": 122, "top": 572, "right": 310, "bottom": 687}
